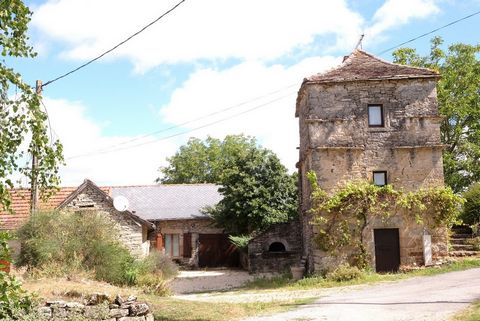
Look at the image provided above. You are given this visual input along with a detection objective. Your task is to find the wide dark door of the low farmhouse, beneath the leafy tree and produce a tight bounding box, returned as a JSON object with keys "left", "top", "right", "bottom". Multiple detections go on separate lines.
{"left": 198, "top": 234, "right": 240, "bottom": 267}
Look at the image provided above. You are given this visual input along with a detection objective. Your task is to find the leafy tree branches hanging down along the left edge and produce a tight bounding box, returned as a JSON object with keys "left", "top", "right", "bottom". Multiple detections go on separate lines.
{"left": 0, "top": 0, "right": 63, "bottom": 209}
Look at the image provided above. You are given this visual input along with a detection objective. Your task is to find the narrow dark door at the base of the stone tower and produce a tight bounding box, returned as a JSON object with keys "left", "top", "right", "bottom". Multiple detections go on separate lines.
{"left": 373, "top": 228, "right": 400, "bottom": 272}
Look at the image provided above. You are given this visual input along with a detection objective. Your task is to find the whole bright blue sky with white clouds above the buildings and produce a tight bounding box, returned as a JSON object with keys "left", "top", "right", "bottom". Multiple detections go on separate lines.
{"left": 9, "top": 0, "right": 480, "bottom": 185}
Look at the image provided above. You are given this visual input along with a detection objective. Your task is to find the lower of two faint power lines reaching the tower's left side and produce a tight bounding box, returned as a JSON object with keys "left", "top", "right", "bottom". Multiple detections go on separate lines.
{"left": 67, "top": 91, "right": 296, "bottom": 160}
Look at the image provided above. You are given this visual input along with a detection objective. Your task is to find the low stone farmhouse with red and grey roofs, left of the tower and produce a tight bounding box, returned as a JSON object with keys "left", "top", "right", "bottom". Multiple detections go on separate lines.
{"left": 0, "top": 179, "right": 239, "bottom": 267}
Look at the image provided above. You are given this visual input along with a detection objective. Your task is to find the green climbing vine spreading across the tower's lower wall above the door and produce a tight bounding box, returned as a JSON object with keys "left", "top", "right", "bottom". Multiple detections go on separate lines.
{"left": 307, "top": 172, "right": 463, "bottom": 268}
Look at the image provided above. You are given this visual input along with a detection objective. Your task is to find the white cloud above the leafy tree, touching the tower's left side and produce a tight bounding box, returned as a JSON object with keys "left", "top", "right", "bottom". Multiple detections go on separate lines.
{"left": 160, "top": 56, "right": 341, "bottom": 171}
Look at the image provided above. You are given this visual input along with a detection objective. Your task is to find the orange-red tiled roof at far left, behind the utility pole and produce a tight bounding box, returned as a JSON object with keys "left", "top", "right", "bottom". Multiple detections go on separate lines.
{"left": 0, "top": 186, "right": 110, "bottom": 230}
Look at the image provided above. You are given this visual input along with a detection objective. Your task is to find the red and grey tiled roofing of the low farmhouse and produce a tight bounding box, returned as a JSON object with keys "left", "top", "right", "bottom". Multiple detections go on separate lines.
{"left": 0, "top": 180, "right": 222, "bottom": 230}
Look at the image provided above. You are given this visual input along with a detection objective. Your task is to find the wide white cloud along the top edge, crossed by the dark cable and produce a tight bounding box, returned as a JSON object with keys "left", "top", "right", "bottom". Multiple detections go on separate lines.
{"left": 32, "top": 0, "right": 363, "bottom": 71}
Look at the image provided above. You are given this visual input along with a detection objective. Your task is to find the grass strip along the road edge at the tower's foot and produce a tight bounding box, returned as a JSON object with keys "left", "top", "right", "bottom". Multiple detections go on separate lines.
{"left": 244, "top": 258, "right": 480, "bottom": 290}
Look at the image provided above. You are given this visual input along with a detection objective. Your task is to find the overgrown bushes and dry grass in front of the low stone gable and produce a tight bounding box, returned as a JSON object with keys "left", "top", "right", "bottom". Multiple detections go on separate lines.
{"left": 17, "top": 211, "right": 177, "bottom": 294}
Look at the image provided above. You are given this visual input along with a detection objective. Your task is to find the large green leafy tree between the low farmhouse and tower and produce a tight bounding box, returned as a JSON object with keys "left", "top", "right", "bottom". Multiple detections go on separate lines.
{"left": 158, "top": 135, "right": 297, "bottom": 235}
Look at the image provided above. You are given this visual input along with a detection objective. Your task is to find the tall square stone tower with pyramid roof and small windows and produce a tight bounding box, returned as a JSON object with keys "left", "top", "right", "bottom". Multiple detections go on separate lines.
{"left": 296, "top": 50, "right": 447, "bottom": 272}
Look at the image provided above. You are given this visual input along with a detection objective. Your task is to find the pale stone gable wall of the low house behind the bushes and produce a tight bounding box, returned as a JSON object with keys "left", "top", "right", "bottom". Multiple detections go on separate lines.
{"left": 65, "top": 186, "right": 150, "bottom": 257}
